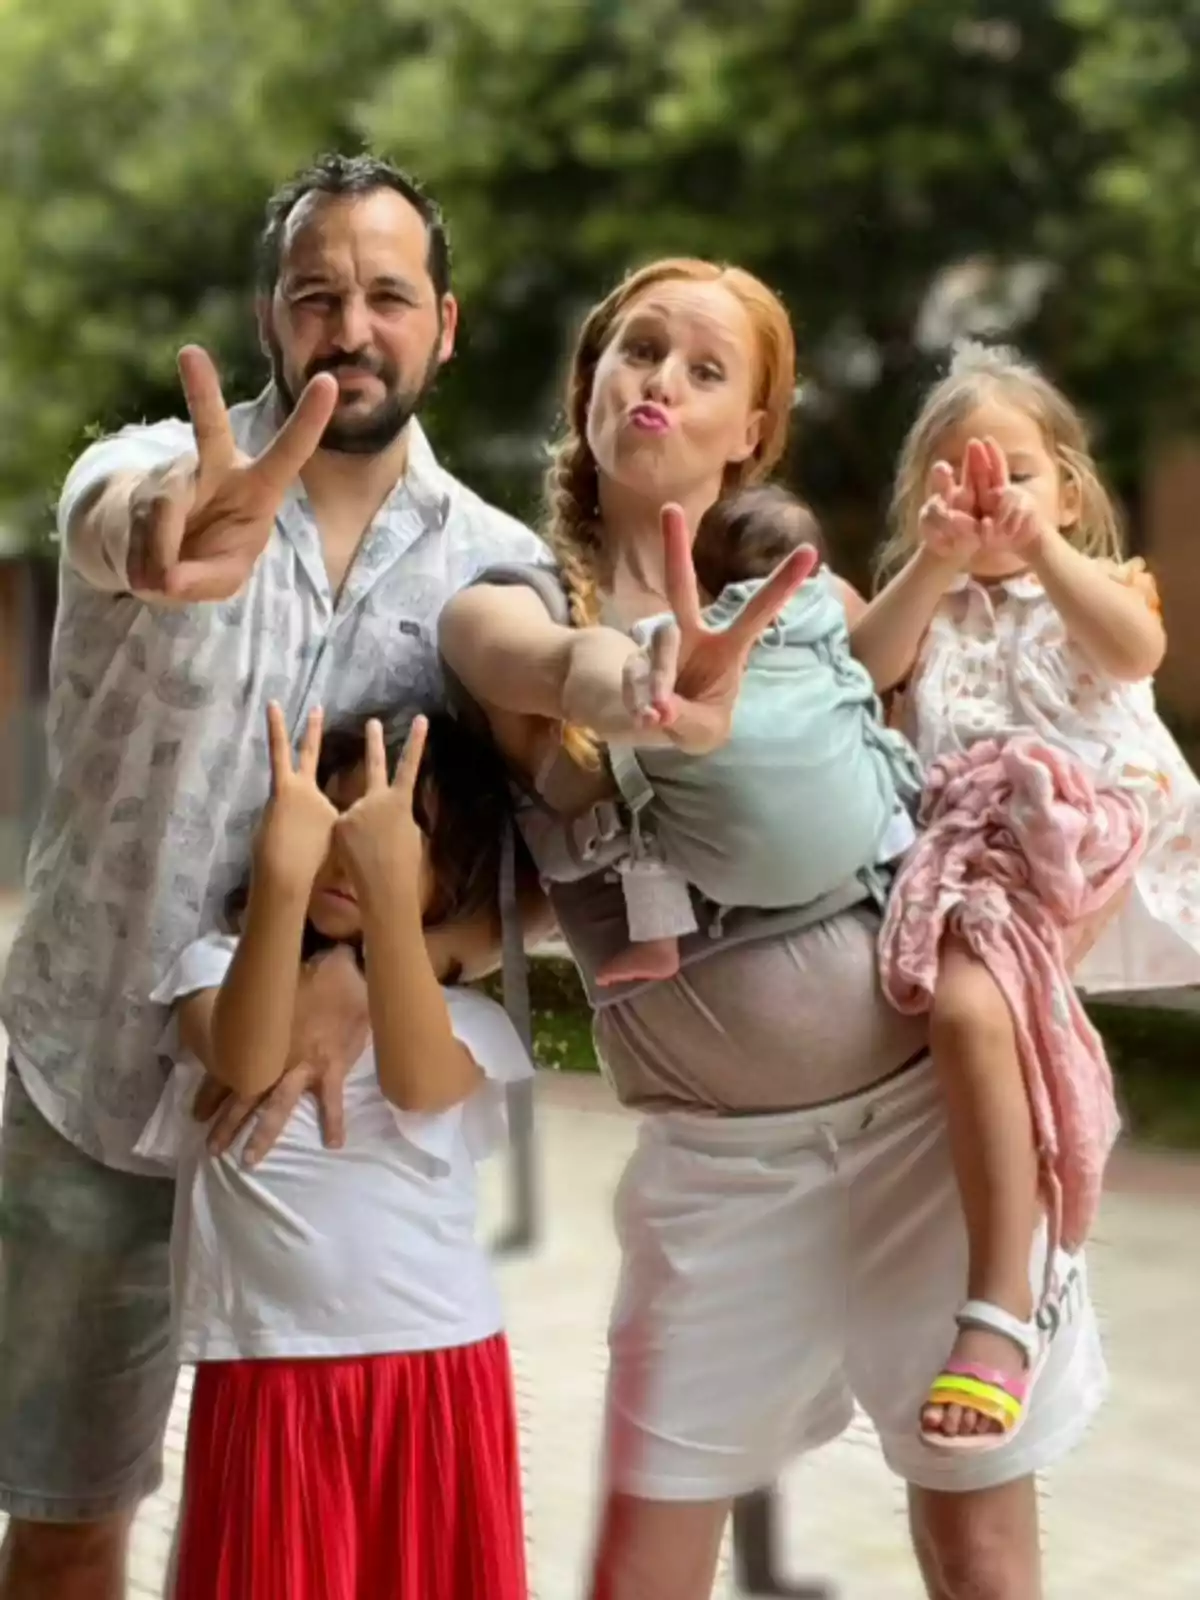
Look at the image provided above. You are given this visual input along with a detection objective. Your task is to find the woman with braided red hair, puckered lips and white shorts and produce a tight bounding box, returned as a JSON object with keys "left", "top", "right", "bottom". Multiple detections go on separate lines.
{"left": 442, "top": 261, "right": 1104, "bottom": 1600}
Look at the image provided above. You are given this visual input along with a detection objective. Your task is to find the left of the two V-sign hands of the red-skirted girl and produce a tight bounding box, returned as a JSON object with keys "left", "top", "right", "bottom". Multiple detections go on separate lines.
{"left": 254, "top": 701, "right": 338, "bottom": 894}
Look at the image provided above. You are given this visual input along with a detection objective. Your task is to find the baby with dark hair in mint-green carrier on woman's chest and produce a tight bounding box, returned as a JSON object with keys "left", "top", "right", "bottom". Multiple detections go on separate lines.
{"left": 597, "top": 485, "right": 922, "bottom": 986}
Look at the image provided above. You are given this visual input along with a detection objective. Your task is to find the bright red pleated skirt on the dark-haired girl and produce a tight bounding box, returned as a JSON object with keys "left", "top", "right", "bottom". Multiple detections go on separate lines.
{"left": 173, "top": 1336, "right": 528, "bottom": 1600}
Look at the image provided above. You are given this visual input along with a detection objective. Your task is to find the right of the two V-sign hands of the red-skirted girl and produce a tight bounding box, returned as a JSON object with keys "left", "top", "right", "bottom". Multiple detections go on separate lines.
{"left": 334, "top": 717, "right": 429, "bottom": 898}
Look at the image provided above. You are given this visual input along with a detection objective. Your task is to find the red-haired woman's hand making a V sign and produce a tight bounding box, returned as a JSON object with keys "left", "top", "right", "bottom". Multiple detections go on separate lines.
{"left": 624, "top": 506, "right": 819, "bottom": 755}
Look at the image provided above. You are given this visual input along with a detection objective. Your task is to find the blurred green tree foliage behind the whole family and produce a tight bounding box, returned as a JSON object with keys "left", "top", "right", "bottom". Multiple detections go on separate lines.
{"left": 0, "top": 0, "right": 1200, "bottom": 578}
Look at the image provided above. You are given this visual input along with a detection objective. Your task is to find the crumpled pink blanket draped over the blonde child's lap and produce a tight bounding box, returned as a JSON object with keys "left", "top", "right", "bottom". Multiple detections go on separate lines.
{"left": 880, "top": 736, "right": 1146, "bottom": 1250}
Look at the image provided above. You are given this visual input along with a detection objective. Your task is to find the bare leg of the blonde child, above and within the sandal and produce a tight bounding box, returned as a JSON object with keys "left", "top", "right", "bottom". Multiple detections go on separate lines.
{"left": 922, "top": 939, "right": 1040, "bottom": 1435}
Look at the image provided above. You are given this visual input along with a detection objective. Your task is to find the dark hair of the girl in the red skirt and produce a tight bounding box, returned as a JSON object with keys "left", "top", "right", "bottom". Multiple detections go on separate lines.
{"left": 226, "top": 709, "right": 522, "bottom": 960}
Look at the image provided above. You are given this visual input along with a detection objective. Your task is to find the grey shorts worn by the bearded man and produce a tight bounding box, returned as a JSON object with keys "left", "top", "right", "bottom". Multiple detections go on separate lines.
{"left": 0, "top": 1061, "right": 178, "bottom": 1522}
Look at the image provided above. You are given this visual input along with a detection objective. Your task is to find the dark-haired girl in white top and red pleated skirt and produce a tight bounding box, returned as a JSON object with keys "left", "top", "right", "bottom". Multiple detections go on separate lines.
{"left": 141, "top": 707, "right": 533, "bottom": 1600}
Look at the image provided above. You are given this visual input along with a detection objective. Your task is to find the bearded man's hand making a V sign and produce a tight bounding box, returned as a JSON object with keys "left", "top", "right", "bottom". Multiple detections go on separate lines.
{"left": 128, "top": 346, "right": 338, "bottom": 605}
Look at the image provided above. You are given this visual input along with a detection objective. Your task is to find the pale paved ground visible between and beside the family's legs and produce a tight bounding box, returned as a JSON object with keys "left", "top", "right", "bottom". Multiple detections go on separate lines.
{"left": 0, "top": 902, "right": 1200, "bottom": 1600}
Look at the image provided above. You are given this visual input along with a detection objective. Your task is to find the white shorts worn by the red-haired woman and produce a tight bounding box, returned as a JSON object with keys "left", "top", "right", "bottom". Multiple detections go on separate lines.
{"left": 608, "top": 1062, "right": 1107, "bottom": 1501}
